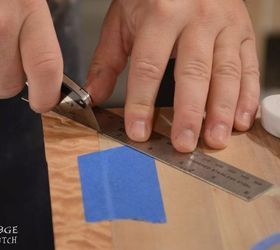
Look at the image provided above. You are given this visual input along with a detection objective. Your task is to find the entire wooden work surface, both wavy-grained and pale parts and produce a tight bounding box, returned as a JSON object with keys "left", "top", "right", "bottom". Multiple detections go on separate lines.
{"left": 43, "top": 108, "right": 280, "bottom": 250}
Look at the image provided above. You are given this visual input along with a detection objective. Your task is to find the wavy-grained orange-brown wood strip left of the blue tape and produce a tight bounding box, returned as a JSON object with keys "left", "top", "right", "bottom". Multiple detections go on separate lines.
{"left": 43, "top": 113, "right": 112, "bottom": 250}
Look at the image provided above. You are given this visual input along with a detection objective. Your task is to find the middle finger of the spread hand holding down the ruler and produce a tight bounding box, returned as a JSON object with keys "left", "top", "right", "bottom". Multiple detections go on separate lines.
{"left": 171, "top": 27, "right": 216, "bottom": 152}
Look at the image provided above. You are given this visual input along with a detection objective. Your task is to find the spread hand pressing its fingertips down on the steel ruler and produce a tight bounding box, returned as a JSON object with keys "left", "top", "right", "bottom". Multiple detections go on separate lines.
{"left": 86, "top": 0, "right": 259, "bottom": 152}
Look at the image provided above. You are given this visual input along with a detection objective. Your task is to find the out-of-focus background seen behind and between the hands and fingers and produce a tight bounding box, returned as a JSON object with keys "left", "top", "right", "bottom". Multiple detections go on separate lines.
{"left": 50, "top": 0, "right": 280, "bottom": 107}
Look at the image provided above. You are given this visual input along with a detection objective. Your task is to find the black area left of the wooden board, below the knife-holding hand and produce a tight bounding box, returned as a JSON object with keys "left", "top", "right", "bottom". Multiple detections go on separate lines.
{"left": 0, "top": 87, "right": 54, "bottom": 250}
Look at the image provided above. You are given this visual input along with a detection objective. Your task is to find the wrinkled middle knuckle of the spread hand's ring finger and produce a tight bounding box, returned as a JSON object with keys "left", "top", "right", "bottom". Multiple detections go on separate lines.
{"left": 213, "top": 60, "right": 241, "bottom": 80}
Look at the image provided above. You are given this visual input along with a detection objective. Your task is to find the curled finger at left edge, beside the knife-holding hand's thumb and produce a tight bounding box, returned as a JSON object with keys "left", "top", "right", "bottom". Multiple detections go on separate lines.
{"left": 0, "top": 1, "right": 24, "bottom": 99}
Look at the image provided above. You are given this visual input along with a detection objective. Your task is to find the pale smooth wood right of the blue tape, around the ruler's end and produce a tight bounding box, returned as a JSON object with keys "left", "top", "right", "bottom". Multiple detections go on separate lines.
{"left": 109, "top": 109, "right": 280, "bottom": 250}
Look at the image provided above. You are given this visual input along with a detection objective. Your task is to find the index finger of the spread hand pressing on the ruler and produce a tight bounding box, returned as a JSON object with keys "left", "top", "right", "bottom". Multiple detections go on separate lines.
{"left": 125, "top": 20, "right": 177, "bottom": 141}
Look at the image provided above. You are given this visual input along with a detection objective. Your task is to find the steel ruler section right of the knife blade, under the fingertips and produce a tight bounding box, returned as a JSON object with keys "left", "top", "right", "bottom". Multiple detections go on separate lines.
{"left": 94, "top": 108, "right": 272, "bottom": 201}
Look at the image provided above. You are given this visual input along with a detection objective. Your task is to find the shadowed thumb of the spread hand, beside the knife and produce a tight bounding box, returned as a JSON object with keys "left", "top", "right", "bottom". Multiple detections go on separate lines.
{"left": 85, "top": 1, "right": 129, "bottom": 104}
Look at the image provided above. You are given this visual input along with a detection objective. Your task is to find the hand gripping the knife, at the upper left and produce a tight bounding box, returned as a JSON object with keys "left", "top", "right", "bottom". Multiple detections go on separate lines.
{"left": 0, "top": 0, "right": 63, "bottom": 112}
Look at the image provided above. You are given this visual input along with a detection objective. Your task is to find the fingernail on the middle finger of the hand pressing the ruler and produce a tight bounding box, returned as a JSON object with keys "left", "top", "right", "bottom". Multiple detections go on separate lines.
{"left": 175, "top": 129, "right": 196, "bottom": 151}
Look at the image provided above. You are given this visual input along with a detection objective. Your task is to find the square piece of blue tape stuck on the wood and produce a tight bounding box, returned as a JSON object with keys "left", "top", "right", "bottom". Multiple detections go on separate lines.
{"left": 78, "top": 147, "right": 166, "bottom": 223}
